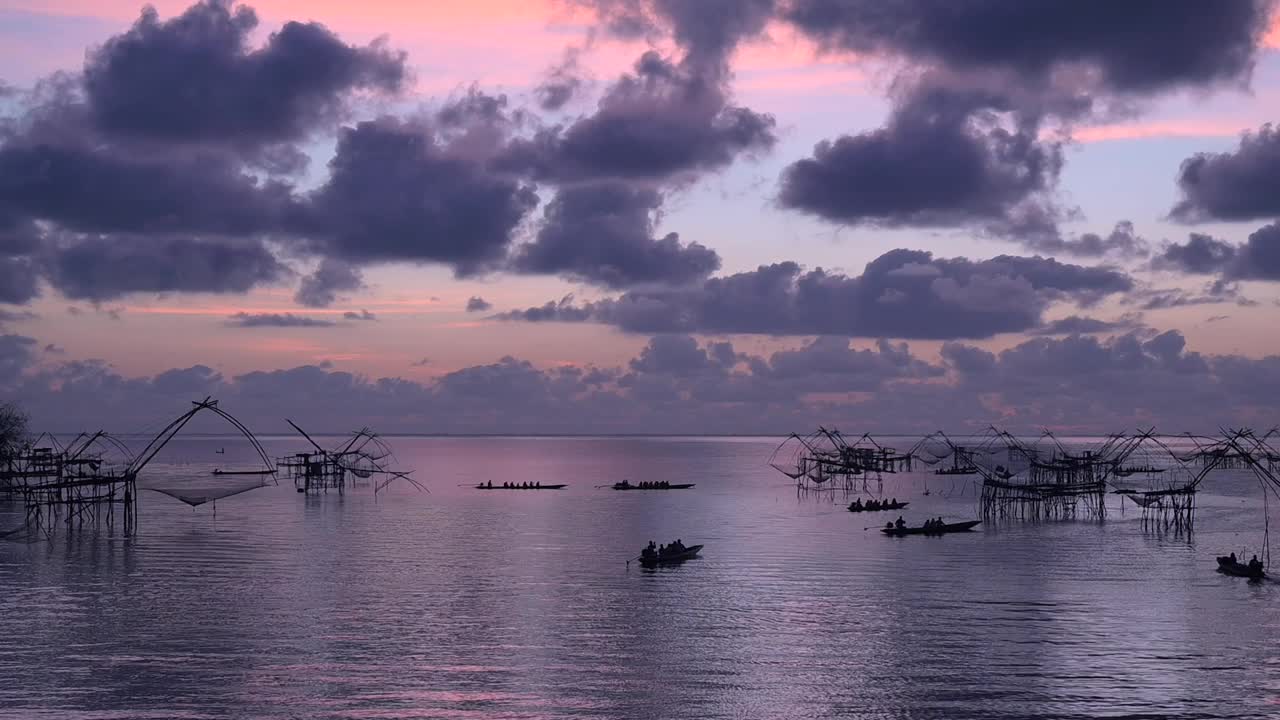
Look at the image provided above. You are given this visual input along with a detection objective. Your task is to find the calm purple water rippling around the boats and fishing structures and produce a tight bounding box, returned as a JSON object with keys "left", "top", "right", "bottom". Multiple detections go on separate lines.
{"left": 0, "top": 438, "right": 1280, "bottom": 719}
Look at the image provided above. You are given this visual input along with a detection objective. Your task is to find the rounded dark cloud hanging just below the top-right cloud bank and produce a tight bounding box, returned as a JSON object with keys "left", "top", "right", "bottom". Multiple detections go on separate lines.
{"left": 780, "top": 82, "right": 1062, "bottom": 234}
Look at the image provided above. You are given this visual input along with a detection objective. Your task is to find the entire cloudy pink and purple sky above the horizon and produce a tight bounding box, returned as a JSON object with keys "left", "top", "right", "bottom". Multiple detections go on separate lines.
{"left": 0, "top": 0, "right": 1280, "bottom": 433}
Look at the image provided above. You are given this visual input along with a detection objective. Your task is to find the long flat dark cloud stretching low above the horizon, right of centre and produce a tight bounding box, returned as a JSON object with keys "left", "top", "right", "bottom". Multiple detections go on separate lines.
{"left": 498, "top": 250, "right": 1133, "bottom": 340}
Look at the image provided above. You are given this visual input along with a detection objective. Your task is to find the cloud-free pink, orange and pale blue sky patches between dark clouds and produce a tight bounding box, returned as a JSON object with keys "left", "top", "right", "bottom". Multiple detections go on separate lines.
{"left": 0, "top": 0, "right": 1280, "bottom": 377}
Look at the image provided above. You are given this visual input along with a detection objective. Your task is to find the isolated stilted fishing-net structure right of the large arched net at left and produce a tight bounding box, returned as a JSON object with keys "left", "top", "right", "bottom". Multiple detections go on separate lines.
{"left": 275, "top": 419, "right": 426, "bottom": 495}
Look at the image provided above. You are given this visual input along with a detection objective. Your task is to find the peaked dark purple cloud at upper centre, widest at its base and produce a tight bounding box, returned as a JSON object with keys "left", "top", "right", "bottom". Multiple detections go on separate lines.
{"left": 502, "top": 51, "right": 777, "bottom": 182}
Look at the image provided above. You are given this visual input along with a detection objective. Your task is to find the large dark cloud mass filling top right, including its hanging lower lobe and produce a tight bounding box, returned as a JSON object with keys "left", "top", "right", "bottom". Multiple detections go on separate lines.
{"left": 780, "top": 0, "right": 1271, "bottom": 234}
